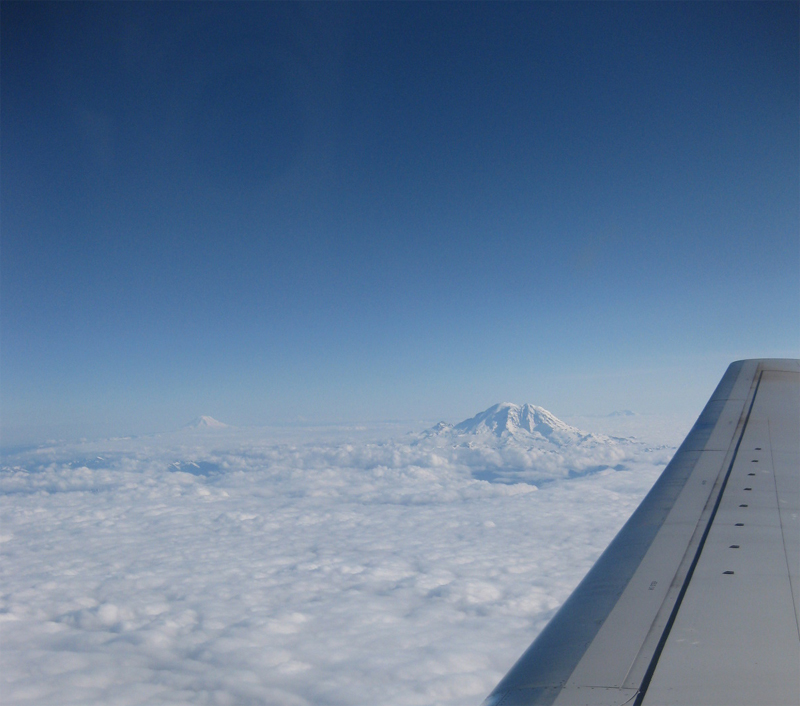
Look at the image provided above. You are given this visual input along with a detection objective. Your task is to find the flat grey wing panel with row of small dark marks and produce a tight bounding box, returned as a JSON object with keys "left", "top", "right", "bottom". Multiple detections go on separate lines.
{"left": 643, "top": 366, "right": 800, "bottom": 706}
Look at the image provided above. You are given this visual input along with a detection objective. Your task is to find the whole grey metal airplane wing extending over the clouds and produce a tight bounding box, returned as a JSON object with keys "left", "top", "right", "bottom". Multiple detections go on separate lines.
{"left": 484, "top": 359, "right": 800, "bottom": 706}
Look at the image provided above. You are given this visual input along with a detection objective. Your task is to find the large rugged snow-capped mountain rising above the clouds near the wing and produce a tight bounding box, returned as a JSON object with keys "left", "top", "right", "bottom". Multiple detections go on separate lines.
{"left": 427, "top": 402, "right": 601, "bottom": 446}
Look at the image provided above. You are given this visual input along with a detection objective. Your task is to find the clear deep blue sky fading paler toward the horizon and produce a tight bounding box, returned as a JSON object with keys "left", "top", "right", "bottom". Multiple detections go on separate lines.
{"left": 0, "top": 2, "right": 800, "bottom": 443}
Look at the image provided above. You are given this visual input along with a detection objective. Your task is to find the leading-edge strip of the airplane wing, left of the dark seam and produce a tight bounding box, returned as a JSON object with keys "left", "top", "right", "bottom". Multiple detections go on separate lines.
{"left": 484, "top": 360, "right": 797, "bottom": 706}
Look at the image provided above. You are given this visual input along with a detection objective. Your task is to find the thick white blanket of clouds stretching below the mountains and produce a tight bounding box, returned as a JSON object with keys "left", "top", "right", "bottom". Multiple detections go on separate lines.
{"left": 0, "top": 420, "right": 673, "bottom": 705}
